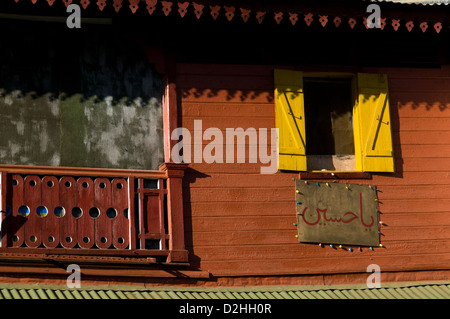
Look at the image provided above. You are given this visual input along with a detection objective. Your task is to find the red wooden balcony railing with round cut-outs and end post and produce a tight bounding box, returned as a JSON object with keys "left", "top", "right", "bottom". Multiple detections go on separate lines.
{"left": 0, "top": 163, "right": 187, "bottom": 263}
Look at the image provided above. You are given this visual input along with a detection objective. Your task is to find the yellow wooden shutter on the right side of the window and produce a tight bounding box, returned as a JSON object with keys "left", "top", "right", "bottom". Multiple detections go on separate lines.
{"left": 353, "top": 73, "right": 394, "bottom": 172}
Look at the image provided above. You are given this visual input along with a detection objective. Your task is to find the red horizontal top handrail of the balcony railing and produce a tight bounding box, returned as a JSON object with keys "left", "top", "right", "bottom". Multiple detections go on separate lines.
{"left": 0, "top": 164, "right": 168, "bottom": 179}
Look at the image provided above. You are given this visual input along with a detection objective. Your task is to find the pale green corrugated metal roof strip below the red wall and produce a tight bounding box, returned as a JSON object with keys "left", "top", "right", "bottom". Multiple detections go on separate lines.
{"left": 0, "top": 282, "right": 450, "bottom": 300}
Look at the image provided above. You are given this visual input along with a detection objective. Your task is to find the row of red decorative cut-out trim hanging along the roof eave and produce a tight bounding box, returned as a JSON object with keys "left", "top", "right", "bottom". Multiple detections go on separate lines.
{"left": 9, "top": 0, "right": 446, "bottom": 33}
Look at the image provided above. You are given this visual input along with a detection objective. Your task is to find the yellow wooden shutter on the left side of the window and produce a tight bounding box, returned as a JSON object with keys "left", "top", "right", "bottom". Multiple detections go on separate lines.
{"left": 274, "top": 70, "right": 306, "bottom": 171}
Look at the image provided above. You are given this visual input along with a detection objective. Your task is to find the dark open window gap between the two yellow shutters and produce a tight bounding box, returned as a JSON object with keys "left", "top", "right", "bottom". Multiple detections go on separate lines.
{"left": 303, "top": 77, "right": 355, "bottom": 155}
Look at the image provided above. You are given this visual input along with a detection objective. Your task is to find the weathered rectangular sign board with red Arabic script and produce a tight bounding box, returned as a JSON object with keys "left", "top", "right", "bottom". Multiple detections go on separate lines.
{"left": 295, "top": 180, "right": 380, "bottom": 246}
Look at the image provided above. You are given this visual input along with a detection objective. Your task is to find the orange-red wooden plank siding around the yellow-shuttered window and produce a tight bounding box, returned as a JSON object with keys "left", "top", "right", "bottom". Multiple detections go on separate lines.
{"left": 176, "top": 64, "right": 450, "bottom": 279}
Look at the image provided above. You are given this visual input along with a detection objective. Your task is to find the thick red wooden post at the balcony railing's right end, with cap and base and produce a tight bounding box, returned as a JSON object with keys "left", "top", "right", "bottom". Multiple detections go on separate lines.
{"left": 159, "top": 163, "right": 188, "bottom": 262}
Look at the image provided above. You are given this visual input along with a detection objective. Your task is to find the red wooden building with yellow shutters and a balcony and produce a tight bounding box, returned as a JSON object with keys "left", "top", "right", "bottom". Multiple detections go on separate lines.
{"left": 0, "top": 0, "right": 450, "bottom": 300}
